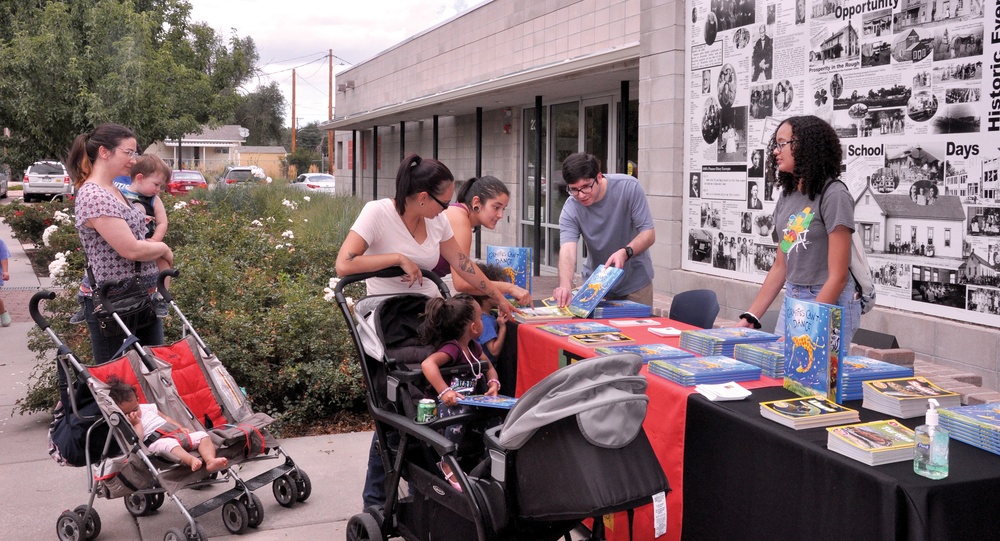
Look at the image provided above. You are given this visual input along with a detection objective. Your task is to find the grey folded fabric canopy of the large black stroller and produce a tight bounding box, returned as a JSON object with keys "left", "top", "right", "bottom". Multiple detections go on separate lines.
{"left": 500, "top": 353, "right": 649, "bottom": 449}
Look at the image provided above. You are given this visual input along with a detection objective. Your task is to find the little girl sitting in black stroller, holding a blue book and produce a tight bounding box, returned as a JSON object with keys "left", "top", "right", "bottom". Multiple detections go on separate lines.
{"left": 420, "top": 293, "right": 500, "bottom": 490}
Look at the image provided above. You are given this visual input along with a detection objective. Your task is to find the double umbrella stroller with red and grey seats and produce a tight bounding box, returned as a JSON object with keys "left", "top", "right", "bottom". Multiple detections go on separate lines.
{"left": 36, "top": 270, "right": 312, "bottom": 541}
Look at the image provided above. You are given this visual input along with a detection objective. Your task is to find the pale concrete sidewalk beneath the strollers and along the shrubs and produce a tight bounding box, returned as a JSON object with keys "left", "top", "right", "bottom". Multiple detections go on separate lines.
{"left": 0, "top": 205, "right": 371, "bottom": 541}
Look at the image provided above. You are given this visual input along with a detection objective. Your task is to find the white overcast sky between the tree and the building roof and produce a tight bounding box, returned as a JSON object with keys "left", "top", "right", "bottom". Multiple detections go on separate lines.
{"left": 188, "top": 0, "right": 483, "bottom": 126}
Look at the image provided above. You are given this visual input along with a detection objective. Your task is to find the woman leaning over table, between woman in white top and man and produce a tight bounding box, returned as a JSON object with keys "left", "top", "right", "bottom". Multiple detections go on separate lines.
{"left": 433, "top": 175, "right": 531, "bottom": 306}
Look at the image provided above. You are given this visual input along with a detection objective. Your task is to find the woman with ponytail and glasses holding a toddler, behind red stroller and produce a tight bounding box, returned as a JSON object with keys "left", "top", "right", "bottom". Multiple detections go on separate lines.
{"left": 66, "top": 124, "right": 174, "bottom": 364}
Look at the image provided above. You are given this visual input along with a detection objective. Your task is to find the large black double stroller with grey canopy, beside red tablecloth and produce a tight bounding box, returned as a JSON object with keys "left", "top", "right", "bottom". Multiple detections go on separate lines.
{"left": 335, "top": 268, "right": 670, "bottom": 541}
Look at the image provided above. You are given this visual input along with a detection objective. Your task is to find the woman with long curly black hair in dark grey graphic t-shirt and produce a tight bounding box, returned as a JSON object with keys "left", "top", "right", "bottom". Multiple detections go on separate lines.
{"left": 739, "top": 115, "right": 861, "bottom": 345}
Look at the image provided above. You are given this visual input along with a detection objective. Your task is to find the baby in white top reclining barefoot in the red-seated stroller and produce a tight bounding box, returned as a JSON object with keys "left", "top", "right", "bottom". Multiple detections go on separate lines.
{"left": 108, "top": 376, "right": 229, "bottom": 472}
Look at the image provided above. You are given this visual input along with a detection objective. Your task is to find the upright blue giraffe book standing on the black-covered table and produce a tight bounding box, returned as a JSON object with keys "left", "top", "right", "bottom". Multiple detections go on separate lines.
{"left": 784, "top": 297, "right": 845, "bottom": 404}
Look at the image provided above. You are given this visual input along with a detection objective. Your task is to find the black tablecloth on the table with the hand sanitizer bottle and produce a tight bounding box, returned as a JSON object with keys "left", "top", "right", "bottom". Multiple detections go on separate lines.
{"left": 682, "top": 387, "right": 1000, "bottom": 541}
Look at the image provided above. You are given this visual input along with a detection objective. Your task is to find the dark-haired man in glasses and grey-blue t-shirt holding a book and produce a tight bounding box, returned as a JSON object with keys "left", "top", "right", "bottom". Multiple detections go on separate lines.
{"left": 552, "top": 152, "right": 656, "bottom": 306}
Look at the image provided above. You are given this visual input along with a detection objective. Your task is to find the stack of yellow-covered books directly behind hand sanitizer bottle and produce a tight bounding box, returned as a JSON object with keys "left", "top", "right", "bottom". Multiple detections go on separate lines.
{"left": 861, "top": 376, "right": 962, "bottom": 419}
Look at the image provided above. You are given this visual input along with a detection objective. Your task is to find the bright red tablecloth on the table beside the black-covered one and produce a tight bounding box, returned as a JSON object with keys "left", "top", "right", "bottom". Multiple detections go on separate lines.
{"left": 516, "top": 318, "right": 782, "bottom": 541}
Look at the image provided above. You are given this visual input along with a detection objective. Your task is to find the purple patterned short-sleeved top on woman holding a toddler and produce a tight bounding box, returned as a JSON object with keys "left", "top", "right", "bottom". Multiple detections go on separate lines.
{"left": 76, "top": 182, "right": 157, "bottom": 297}
